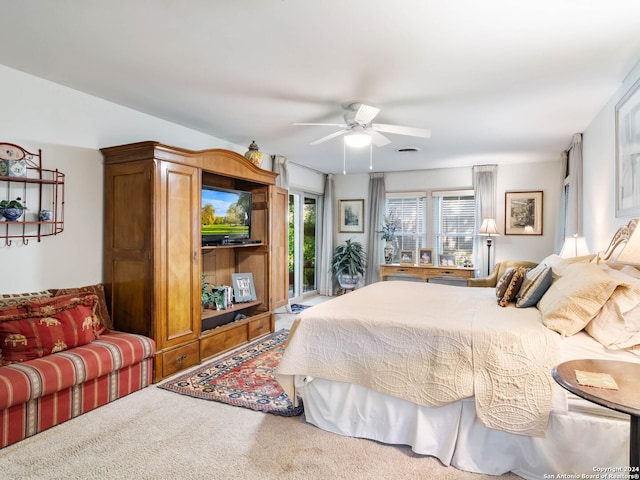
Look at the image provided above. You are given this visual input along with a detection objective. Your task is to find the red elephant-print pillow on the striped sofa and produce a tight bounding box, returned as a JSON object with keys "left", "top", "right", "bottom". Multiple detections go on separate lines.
{"left": 0, "top": 295, "right": 98, "bottom": 365}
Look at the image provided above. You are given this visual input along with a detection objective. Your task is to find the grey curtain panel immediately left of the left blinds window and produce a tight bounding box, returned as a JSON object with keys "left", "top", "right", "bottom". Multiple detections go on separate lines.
{"left": 364, "top": 173, "right": 386, "bottom": 285}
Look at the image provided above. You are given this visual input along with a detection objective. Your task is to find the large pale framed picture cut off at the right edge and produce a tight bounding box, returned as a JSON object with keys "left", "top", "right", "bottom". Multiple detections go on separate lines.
{"left": 616, "top": 80, "right": 640, "bottom": 217}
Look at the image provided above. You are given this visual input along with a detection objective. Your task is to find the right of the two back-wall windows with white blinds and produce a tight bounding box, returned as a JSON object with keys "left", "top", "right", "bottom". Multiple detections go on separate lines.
{"left": 432, "top": 190, "right": 476, "bottom": 260}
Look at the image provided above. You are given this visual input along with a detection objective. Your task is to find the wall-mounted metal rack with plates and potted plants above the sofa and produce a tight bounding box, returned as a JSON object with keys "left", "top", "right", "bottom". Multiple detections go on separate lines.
{"left": 0, "top": 143, "right": 65, "bottom": 246}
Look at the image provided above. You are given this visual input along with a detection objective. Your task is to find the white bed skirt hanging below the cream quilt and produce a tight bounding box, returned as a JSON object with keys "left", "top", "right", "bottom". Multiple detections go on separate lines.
{"left": 296, "top": 377, "right": 629, "bottom": 480}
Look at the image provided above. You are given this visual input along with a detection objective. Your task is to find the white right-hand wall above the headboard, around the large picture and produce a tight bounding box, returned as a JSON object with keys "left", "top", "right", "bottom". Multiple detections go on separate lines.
{"left": 582, "top": 63, "right": 640, "bottom": 252}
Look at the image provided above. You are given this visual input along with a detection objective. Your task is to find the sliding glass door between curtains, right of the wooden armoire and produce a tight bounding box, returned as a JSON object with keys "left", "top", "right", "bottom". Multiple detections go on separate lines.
{"left": 289, "top": 191, "right": 319, "bottom": 303}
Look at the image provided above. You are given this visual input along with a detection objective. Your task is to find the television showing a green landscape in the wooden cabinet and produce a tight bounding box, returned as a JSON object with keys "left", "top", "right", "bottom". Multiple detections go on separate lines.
{"left": 200, "top": 186, "right": 252, "bottom": 243}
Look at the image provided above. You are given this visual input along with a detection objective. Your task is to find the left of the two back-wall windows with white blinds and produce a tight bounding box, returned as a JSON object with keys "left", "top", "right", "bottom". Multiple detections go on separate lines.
{"left": 386, "top": 192, "right": 426, "bottom": 263}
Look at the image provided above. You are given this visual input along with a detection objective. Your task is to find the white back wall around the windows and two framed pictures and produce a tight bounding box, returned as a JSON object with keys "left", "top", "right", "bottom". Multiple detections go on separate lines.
{"left": 335, "top": 159, "right": 571, "bottom": 272}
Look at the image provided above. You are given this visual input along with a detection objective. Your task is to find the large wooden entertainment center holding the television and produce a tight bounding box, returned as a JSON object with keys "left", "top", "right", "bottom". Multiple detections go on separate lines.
{"left": 101, "top": 142, "right": 288, "bottom": 382}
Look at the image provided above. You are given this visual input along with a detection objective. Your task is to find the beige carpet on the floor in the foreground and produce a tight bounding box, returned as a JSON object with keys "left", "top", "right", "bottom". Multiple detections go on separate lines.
{"left": 0, "top": 302, "right": 520, "bottom": 480}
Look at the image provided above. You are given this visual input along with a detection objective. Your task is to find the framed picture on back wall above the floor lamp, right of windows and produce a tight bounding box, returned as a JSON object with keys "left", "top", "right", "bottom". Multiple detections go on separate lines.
{"left": 504, "top": 191, "right": 542, "bottom": 235}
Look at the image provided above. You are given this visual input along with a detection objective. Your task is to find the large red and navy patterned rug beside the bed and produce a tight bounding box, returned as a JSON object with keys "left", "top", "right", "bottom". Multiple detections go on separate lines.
{"left": 158, "top": 330, "right": 303, "bottom": 417}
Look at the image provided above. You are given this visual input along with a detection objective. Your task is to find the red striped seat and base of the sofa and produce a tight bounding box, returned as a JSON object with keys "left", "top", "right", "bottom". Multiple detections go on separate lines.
{"left": 0, "top": 332, "right": 155, "bottom": 448}
